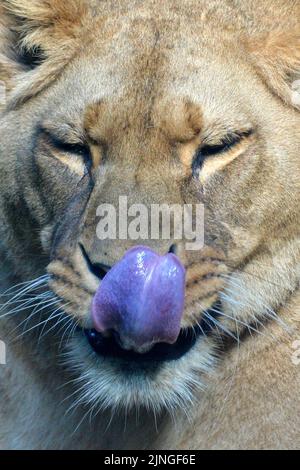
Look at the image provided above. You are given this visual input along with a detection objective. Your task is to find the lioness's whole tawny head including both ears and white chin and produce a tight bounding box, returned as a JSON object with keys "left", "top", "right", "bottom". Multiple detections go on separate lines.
{"left": 0, "top": 0, "right": 300, "bottom": 409}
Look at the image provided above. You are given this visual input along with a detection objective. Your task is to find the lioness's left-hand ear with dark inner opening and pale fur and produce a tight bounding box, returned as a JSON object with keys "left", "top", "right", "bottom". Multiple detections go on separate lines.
{"left": 0, "top": 0, "right": 88, "bottom": 106}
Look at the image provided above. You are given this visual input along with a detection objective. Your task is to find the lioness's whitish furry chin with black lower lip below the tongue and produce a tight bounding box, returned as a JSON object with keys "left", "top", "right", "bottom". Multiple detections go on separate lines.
{"left": 62, "top": 331, "right": 215, "bottom": 412}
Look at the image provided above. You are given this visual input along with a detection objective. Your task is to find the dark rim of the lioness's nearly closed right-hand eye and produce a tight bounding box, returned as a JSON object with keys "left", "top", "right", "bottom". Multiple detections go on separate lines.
{"left": 192, "top": 129, "right": 254, "bottom": 174}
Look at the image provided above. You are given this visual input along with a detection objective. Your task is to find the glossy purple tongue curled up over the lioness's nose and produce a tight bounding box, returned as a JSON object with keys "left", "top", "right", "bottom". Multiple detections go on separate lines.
{"left": 92, "top": 246, "right": 185, "bottom": 352}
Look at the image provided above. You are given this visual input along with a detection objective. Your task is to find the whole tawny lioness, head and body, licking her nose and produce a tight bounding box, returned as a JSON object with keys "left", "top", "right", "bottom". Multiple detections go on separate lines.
{"left": 0, "top": 0, "right": 300, "bottom": 450}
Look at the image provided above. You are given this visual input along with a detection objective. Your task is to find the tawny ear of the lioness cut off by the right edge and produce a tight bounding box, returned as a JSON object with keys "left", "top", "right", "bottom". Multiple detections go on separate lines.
{"left": 248, "top": 31, "right": 300, "bottom": 109}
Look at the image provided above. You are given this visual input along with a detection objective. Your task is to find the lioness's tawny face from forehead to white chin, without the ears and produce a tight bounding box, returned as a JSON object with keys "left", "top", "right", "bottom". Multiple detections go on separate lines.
{"left": 1, "top": 1, "right": 300, "bottom": 409}
